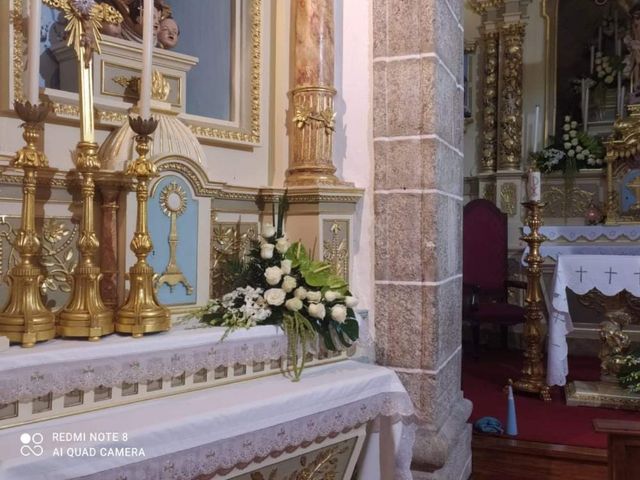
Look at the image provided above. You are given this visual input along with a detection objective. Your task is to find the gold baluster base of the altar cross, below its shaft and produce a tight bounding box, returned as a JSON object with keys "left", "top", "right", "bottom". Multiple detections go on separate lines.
{"left": 57, "top": 142, "right": 114, "bottom": 341}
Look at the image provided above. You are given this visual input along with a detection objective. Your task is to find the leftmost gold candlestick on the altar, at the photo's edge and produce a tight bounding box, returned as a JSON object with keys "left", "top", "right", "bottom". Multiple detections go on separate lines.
{"left": 0, "top": 101, "right": 56, "bottom": 347}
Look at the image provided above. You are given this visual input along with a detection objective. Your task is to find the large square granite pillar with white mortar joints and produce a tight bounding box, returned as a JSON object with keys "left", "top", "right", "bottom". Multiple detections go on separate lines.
{"left": 373, "top": 0, "right": 471, "bottom": 480}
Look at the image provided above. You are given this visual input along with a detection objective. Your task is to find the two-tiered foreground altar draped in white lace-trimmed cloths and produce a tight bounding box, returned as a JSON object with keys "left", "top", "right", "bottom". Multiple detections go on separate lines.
{"left": 0, "top": 327, "right": 414, "bottom": 480}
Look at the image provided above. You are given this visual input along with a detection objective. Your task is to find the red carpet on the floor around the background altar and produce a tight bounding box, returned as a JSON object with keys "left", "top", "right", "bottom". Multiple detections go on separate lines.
{"left": 462, "top": 351, "right": 640, "bottom": 448}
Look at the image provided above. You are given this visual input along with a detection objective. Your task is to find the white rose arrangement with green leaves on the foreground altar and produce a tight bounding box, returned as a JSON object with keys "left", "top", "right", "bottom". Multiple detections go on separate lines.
{"left": 191, "top": 196, "right": 359, "bottom": 381}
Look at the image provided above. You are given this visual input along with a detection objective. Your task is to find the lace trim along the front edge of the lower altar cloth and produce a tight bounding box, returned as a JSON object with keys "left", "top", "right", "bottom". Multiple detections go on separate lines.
{"left": 78, "top": 392, "right": 416, "bottom": 480}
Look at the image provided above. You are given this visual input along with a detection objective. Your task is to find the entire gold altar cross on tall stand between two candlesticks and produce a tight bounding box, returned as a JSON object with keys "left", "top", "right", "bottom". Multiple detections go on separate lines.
{"left": 43, "top": 0, "right": 122, "bottom": 340}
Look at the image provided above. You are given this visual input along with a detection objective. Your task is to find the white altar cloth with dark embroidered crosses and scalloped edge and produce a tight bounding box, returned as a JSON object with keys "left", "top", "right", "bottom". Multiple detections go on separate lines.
{"left": 547, "top": 255, "right": 640, "bottom": 385}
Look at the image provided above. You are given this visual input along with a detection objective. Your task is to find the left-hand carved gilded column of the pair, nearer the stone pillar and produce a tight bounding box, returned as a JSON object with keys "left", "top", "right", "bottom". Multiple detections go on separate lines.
{"left": 479, "top": 28, "right": 500, "bottom": 173}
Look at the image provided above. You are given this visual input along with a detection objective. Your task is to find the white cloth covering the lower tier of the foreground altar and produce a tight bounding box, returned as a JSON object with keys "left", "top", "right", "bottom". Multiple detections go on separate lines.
{"left": 0, "top": 360, "right": 414, "bottom": 480}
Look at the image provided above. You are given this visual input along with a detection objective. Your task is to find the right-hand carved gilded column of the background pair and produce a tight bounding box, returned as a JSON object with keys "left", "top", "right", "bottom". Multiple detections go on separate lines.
{"left": 498, "top": 21, "right": 525, "bottom": 170}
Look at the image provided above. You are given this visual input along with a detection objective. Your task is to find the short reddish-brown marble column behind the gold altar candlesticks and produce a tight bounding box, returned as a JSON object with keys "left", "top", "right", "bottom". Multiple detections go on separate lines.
{"left": 99, "top": 184, "right": 120, "bottom": 309}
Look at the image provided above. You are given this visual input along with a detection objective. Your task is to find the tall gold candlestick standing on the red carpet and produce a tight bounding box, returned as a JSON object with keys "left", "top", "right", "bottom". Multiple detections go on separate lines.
{"left": 513, "top": 201, "right": 551, "bottom": 402}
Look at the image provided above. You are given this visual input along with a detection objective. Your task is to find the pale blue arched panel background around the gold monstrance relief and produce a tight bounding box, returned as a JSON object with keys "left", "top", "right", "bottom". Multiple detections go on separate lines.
{"left": 149, "top": 175, "right": 198, "bottom": 305}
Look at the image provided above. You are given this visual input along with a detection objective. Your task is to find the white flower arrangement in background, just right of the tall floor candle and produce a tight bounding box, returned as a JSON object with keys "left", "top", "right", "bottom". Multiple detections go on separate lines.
{"left": 533, "top": 115, "right": 604, "bottom": 173}
